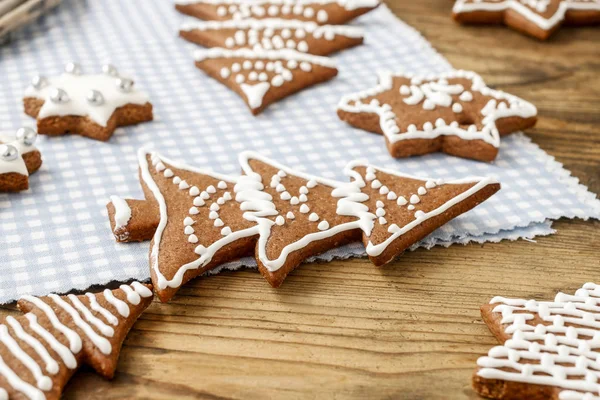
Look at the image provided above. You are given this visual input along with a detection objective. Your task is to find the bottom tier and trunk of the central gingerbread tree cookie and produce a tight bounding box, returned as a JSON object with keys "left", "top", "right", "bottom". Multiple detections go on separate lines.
{"left": 108, "top": 149, "right": 258, "bottom": 301}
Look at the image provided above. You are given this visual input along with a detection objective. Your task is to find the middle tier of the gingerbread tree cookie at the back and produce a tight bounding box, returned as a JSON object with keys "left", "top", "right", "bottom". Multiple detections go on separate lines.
{"left": 179, "top": 19, "right": 363, "bottom": 56}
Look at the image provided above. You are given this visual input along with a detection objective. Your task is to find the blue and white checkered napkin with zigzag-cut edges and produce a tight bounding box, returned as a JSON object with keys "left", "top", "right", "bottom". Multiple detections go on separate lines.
{"left": 0, "top": 0, "right": 600, "bottom": 303}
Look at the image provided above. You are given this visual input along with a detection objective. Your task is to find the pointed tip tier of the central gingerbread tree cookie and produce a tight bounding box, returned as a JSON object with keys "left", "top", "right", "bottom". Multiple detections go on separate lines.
{"left": 334, "top": 161, "right": 500, "bottom": 266}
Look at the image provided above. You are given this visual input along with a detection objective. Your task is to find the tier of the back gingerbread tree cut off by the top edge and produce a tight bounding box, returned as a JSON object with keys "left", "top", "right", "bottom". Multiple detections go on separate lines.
{"left": 175, "top": 0, "right": 379, "bottom": 25}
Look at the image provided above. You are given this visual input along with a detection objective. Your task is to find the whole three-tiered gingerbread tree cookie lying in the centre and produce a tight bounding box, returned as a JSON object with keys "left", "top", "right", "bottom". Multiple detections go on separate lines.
{"left": 107, "top": 149, "right": 500, "bottom": 294}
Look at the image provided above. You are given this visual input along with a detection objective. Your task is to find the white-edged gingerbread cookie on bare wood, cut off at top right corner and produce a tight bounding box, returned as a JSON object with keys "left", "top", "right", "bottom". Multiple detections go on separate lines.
{"left": 452, "top": 0, "right": 600, "bottom": 40}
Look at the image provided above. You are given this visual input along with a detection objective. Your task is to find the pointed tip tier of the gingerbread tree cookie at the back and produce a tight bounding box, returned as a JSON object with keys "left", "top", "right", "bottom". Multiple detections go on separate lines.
{"left": 195, "top": 47, "right": 337, "bottom": 115}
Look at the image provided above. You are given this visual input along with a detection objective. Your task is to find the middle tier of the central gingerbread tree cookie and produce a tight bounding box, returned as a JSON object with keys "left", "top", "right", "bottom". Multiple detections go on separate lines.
{"left": 235, "top": 152, "right": 361, "bottom": 287}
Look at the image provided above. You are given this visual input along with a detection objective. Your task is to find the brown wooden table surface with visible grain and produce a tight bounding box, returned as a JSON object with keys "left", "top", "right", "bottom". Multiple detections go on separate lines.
{"left": 4, "top": 0, "right": 600, "bottom": 400}
